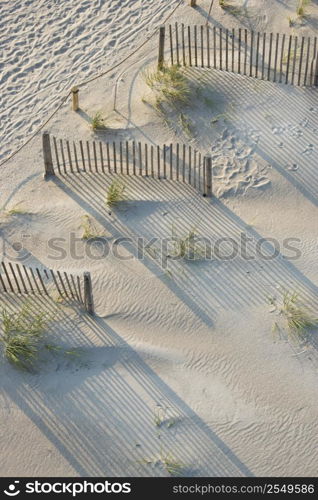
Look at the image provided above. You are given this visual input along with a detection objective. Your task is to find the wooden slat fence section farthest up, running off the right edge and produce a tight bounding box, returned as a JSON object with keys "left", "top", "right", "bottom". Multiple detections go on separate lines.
{"left": 158, "top": 23, "right": 318, "bottom": 87}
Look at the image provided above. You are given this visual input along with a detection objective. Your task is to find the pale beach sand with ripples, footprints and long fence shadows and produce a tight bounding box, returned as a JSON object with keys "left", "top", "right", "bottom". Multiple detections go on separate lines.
{"left": 0, "top": 0, "right": 318, "bottom": 476}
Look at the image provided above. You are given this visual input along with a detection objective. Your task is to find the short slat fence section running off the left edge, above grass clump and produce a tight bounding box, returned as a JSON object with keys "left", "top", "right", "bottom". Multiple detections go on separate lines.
{"left": 0, "top": 262, "right": 94, "bottom": 314}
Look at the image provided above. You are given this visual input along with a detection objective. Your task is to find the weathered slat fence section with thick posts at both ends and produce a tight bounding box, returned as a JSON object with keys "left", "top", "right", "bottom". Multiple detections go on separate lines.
{"left": 43, "top": 132, "right": 212, "bottom": 196}
